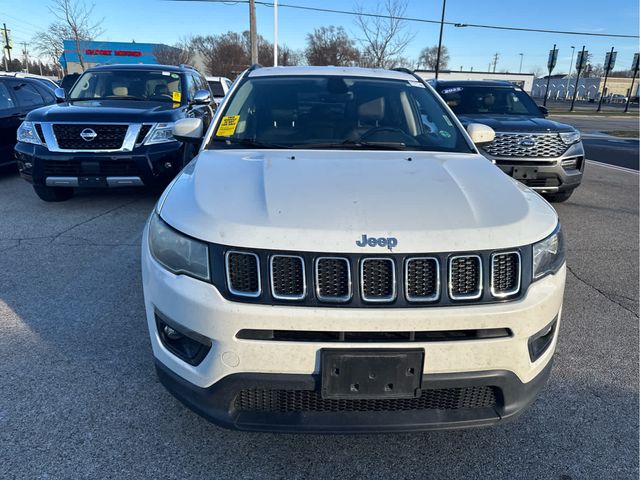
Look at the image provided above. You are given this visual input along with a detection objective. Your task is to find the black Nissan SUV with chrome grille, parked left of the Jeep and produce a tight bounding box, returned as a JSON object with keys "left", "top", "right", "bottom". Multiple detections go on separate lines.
{"left": 15, "top": 65, "right": 213, "bottom": 201}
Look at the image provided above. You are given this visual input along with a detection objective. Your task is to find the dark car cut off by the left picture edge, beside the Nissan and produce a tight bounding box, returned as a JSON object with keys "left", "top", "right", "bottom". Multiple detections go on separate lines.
{"left": 0, "top": 75, "right": 56, "bottom": 166}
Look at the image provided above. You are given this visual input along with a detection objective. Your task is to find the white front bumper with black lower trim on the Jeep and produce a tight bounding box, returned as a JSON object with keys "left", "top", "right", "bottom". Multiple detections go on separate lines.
{"left": 142, "top": 231, "right": 566, "bottom": 432}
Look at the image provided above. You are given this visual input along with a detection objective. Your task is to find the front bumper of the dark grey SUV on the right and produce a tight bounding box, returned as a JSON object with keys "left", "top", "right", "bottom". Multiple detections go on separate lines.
{"left": 481, "top": 142, "right": 585, "bottom": 193}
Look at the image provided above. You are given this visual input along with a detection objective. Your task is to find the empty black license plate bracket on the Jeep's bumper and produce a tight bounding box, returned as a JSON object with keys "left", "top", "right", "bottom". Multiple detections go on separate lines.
{"left": 320, "top": 348, "right": 424, "bottom": 399}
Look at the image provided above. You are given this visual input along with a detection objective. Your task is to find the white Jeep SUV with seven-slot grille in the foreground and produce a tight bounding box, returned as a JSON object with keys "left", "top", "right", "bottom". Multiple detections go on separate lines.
{"left": 142, "top": 67, "right": 565, "bottom": 432}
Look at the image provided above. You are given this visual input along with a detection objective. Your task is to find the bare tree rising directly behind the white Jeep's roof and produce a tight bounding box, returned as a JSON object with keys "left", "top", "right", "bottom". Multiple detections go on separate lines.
{"left": 356, "top": 0, "right": 413, "bottom": 68}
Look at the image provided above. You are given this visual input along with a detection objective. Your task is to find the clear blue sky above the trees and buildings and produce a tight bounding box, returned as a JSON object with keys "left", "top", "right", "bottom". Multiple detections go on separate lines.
{"left": 0, "top": 0, "right": 640, "bottom": 73}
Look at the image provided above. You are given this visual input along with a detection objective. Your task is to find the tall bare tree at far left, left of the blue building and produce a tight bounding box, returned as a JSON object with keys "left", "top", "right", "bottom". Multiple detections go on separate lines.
{"left": 49, "top": 0, "right": 103, "bottom": 71}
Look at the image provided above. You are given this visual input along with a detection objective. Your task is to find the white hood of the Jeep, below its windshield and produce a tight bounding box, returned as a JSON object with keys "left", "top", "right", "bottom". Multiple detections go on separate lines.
{"left": 160, "top": 150, "right": 558, "bottom": 253}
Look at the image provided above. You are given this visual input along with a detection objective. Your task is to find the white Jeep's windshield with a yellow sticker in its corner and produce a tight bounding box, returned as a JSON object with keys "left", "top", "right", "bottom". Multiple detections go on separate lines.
{"left": 208, "top": 76, "right": 473, "bottom": 152}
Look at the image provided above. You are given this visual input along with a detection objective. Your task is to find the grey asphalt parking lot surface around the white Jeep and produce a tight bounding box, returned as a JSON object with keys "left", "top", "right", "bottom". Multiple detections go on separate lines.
{"left": 0, "top": 165, "right": 639, "bottom": 480}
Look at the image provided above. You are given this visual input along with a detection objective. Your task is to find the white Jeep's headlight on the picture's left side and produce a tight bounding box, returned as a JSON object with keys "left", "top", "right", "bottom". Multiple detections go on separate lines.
{"left": 149, "top": 212, "right": 209, "bottom": 280}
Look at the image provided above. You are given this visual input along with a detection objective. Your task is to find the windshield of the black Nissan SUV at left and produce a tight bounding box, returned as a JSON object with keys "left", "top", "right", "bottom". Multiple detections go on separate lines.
{"left": 69, "top": 70, "right": 182, "bottom": 103}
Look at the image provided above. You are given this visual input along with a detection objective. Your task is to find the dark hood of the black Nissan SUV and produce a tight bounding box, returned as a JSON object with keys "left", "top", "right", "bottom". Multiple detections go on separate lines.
{"left": 27, "top": 100, "right": 186, "bottom": 123}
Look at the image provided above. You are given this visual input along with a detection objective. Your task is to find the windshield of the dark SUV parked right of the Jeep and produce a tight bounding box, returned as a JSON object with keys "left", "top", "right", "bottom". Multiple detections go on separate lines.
{"left": 438, "top": 85, "right": 543, "bottom": 117}
